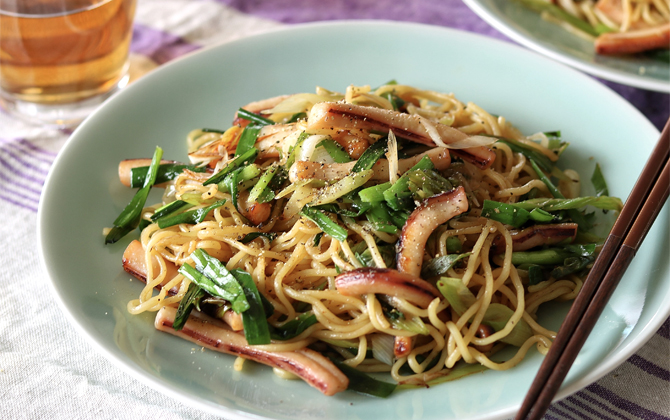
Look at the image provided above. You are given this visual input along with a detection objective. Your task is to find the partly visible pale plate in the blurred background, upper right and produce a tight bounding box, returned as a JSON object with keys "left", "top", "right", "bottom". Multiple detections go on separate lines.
{"left": 463, "top": 0, "right": 670, "bottom": 92}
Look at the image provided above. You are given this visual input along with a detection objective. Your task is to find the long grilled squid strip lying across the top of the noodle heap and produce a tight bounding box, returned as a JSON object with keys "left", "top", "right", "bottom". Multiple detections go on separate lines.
{"left": 307, "top": 102, "right": 495, "bottom": 169}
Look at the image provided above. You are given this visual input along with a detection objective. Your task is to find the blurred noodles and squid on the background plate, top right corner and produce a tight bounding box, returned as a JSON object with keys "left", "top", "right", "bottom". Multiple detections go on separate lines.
{"left": 521, "top": 0, "right": 670, "bottom": 55}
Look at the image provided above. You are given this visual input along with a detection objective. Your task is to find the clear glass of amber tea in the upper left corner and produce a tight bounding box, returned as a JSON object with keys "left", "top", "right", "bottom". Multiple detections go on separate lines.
{"left": 0, "top": 0, "right": 136, "bottom": 126}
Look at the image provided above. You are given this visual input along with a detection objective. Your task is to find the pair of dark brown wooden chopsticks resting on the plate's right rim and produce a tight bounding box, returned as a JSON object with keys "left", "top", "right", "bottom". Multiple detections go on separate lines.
{"left": 515, "top": 120, "right": 670, "bottom": 420}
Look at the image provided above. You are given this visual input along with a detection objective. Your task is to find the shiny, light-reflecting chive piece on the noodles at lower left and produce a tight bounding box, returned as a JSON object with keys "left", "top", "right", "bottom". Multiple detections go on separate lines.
{"left": 189, "top": 248, "right": 249, "bottom": 313}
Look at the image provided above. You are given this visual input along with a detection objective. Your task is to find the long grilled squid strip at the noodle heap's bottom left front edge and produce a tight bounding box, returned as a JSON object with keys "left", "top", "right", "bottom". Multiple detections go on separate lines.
{"left": 154, "top": 306, "right": 349, "bottom": 396}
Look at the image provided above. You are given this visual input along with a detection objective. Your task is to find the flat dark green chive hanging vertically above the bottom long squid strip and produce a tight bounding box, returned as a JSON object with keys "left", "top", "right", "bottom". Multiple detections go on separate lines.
{"left": 231, "top": 269, "right": 270, "bottom": 345}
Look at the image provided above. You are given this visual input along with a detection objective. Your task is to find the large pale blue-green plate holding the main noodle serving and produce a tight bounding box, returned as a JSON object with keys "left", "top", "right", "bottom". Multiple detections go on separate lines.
{"left": 38, "top": 21, "right": 670, "bottom": 420}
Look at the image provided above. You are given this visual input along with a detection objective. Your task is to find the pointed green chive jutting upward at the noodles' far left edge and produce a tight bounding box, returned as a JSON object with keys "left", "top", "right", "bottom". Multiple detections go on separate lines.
{"left": 105, "top": 147, "right": 163, "bottom": 244}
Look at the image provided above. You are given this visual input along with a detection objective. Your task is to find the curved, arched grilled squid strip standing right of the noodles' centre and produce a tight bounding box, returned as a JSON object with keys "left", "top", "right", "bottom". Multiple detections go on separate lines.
{"left": 396, "top": 187, "right": 468, "bottom": 277}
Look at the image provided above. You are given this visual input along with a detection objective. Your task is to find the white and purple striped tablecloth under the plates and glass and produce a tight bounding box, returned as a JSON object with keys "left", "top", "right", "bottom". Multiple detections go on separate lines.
{"left": 0, "top": 0, "right": 670, "bottom": 419}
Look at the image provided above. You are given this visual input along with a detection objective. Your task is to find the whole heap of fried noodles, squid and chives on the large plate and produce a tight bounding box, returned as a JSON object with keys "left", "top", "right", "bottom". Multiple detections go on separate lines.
{"left": 105, "top": 82, "right": 622, "bottom": 397}
